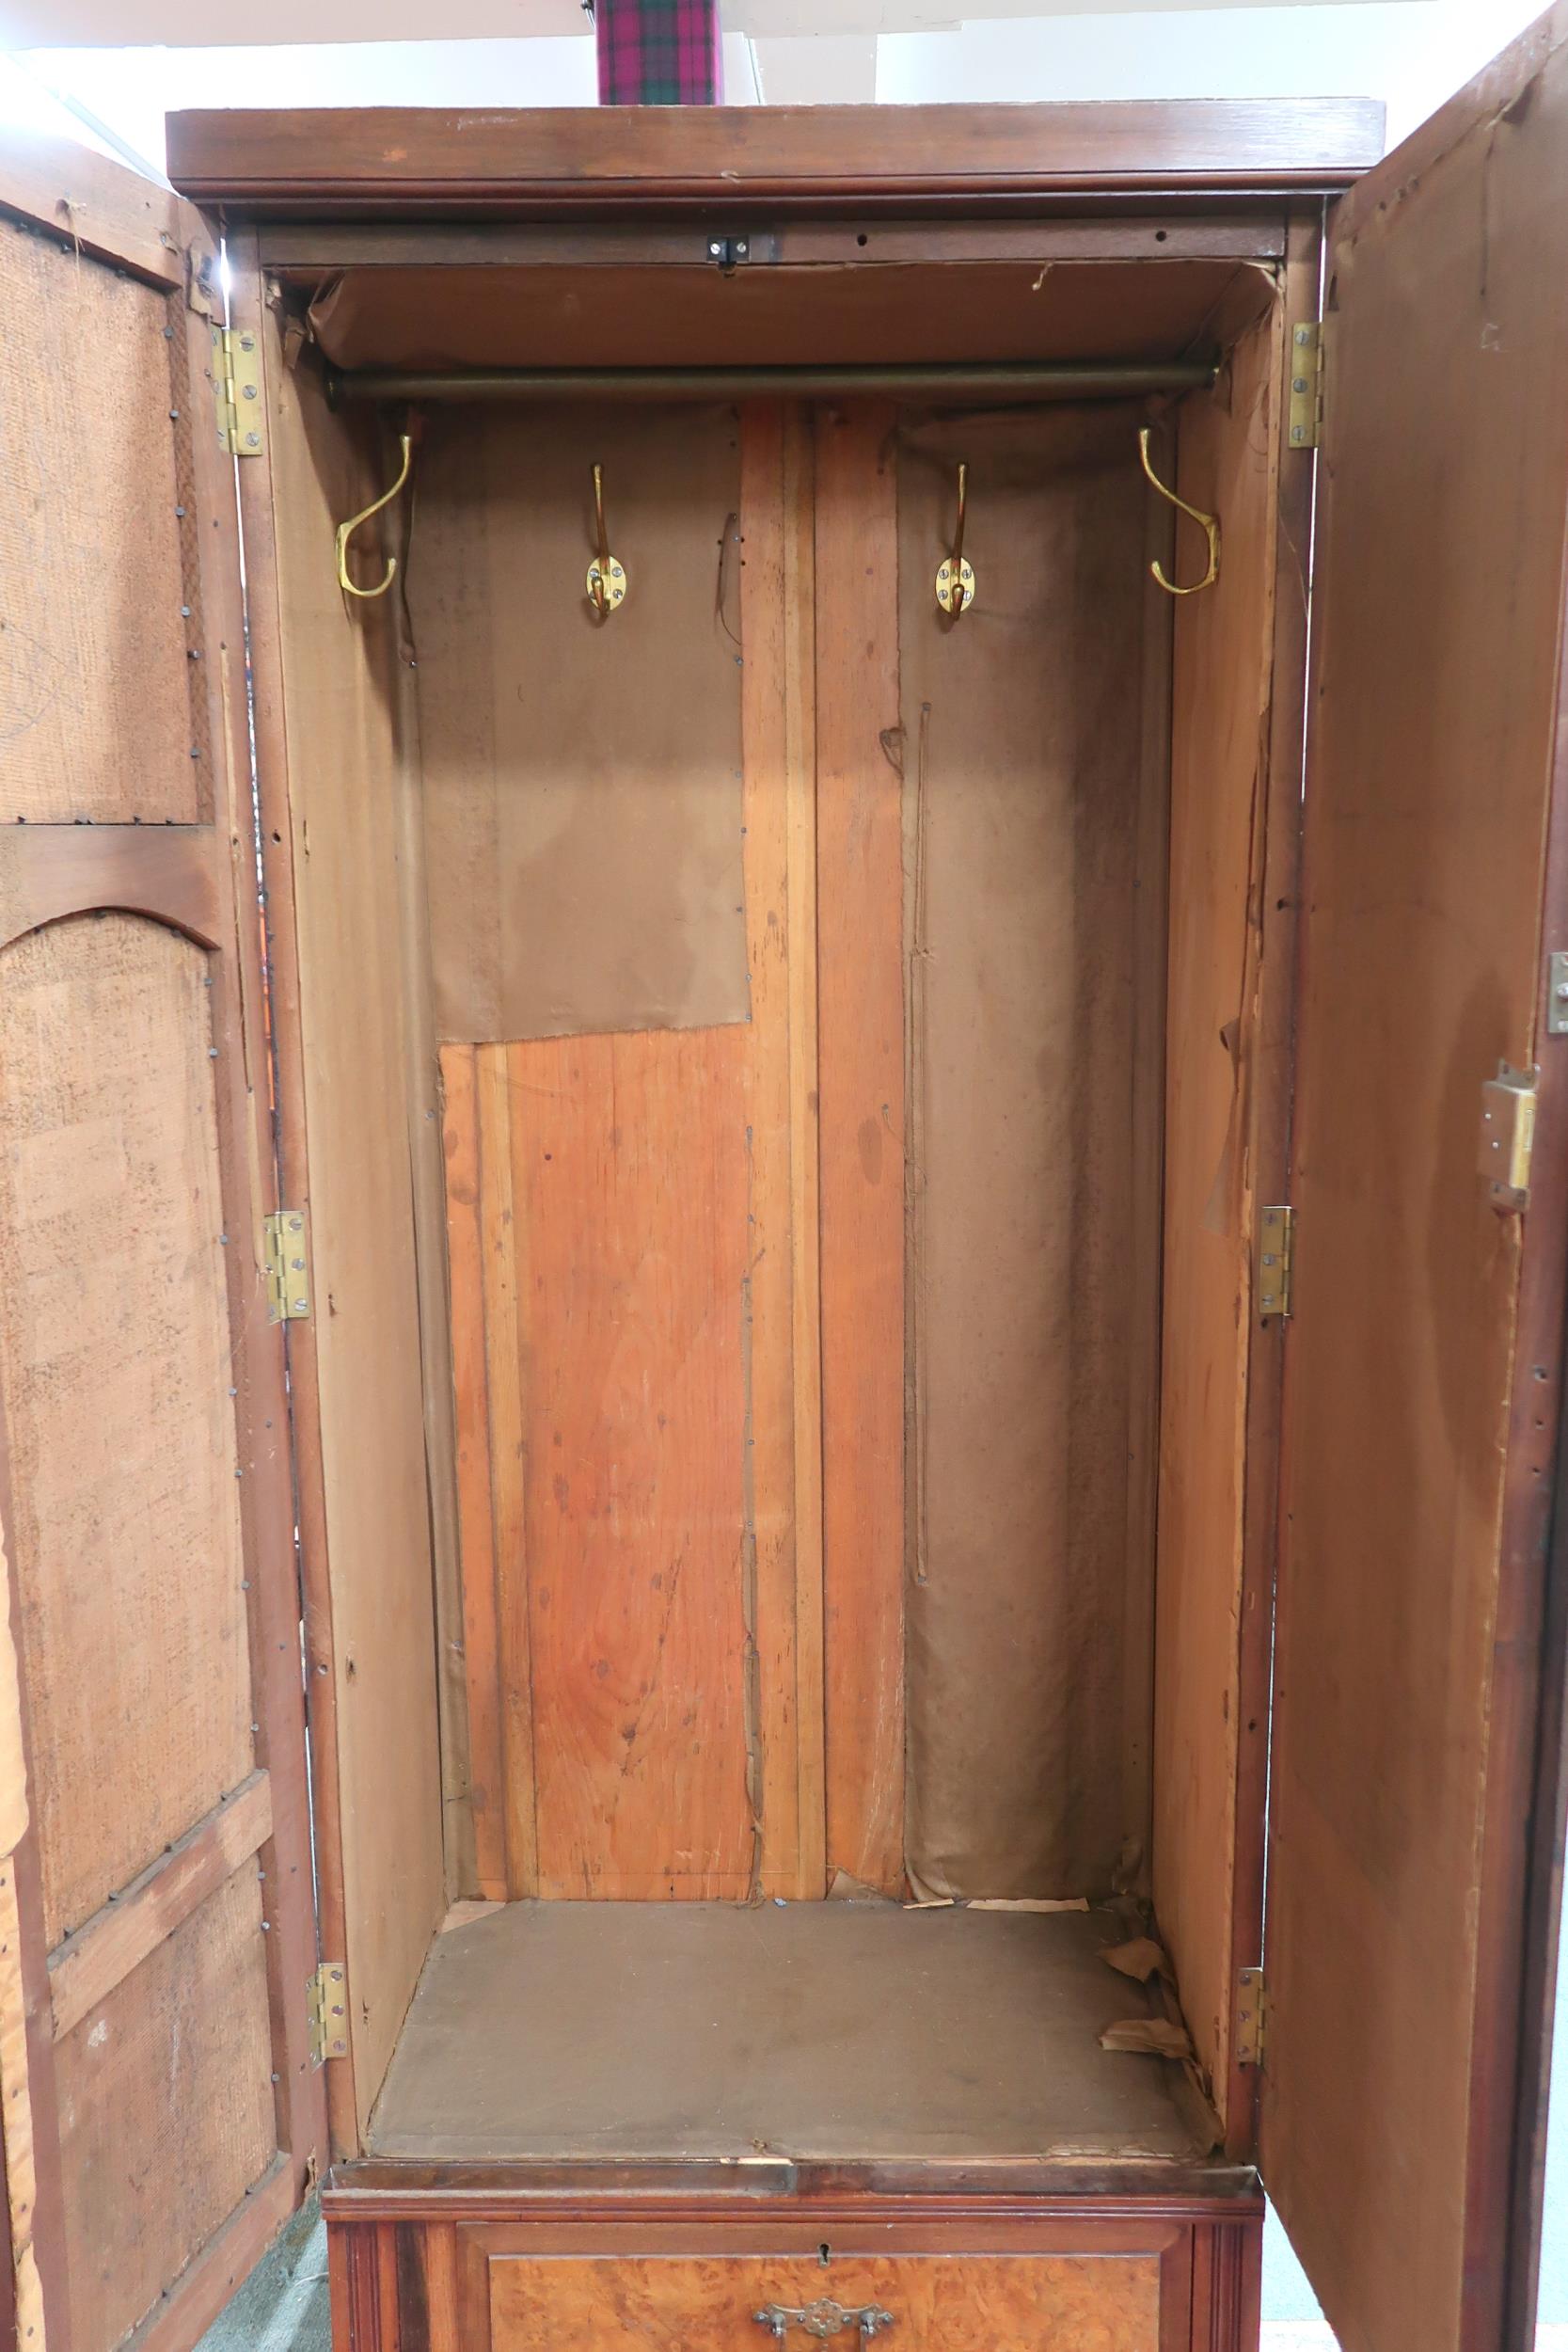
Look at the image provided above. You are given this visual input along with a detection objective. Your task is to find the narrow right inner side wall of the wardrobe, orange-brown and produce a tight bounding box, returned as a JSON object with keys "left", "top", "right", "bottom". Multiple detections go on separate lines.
{"left": 1154, "top": 279, "right": 1300, "bottom": 2122}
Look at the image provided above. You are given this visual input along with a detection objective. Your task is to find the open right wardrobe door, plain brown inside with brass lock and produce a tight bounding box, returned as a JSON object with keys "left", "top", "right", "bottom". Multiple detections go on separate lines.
{"left": 1260, "top": 8, "right": 1568, "bottom": 2352}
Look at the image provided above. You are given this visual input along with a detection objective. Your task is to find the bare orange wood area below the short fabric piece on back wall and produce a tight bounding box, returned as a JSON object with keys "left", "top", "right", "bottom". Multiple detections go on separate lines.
{"left": 449, "top": 1025, "right": 752, "bottom": 1899}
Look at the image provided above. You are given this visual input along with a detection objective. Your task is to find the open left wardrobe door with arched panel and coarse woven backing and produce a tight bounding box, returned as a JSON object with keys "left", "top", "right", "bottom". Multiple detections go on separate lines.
{"left": 0, "top": 139, "right": 325, "bottom": 2352}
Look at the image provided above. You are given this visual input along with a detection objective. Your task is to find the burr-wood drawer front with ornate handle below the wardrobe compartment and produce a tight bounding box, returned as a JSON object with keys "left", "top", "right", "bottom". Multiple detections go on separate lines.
{"left": 486, "top": 2253, "right": 1162, "bottom": 2352}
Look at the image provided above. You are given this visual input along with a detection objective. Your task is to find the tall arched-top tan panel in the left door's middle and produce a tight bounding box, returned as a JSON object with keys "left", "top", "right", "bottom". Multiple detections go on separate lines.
{"left": 0, "top": 915, "right": 251, "bottom": 1946}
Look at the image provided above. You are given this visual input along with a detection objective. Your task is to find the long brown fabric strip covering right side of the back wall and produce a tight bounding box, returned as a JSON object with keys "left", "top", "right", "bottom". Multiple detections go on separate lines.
{"left": 900, "top": 409, "right": 1154, "bottom": 1896}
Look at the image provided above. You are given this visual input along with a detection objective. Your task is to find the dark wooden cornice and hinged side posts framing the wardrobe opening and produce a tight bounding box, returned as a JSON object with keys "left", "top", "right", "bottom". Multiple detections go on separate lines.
{"left": 181, "top": 102, "right": 1354, "bottom": 2178}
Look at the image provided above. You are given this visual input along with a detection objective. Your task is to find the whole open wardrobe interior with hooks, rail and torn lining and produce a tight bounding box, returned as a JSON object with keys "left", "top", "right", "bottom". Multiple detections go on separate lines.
{"left": 255, "top": 230, "right": 1305, "bottom": 2162}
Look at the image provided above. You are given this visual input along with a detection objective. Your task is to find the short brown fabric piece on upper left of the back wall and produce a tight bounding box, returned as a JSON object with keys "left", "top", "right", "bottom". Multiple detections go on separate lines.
{"left": 406, "top": 407, "right": 750, "bottom": 1044}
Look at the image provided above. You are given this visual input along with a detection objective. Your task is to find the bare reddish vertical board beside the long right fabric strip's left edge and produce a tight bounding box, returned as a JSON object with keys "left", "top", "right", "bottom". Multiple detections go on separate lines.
{"left": 816, "top": 403, "right": 905, "bottom": 1894}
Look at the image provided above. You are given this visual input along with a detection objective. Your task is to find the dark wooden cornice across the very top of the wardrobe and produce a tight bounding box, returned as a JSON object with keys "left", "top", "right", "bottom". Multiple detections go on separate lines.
{"left": 159, "top": 99, "right": 1383, "bottom": 219}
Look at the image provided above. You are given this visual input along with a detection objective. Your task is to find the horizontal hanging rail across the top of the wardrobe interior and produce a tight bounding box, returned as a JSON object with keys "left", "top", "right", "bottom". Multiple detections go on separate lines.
{"left": 326, "top": 360, "right": 1220, "bottom": 407}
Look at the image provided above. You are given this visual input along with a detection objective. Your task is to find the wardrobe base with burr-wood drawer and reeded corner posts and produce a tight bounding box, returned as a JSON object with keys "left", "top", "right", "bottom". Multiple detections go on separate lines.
{"left": 329, "top": 2200, "right": 1260, "bottom": 2352}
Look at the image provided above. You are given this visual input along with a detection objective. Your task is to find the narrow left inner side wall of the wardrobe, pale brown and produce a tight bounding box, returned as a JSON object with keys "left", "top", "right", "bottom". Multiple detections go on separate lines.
{"left": 249, "top": 343, "right": 447, "bottom": 2145}
